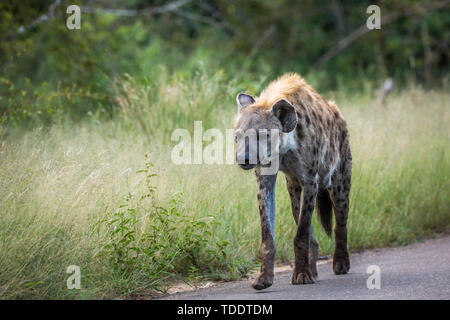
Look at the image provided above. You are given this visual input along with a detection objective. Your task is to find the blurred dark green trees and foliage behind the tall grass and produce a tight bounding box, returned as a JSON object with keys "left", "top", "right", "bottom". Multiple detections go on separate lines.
{"left": 0, "top": 0, "right": 450, "bottom": 126}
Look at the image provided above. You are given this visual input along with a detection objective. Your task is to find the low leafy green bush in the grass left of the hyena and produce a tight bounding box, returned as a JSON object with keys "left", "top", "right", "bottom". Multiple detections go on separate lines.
{"left": 99, "top": 156, "right": 228, "bottom": 290}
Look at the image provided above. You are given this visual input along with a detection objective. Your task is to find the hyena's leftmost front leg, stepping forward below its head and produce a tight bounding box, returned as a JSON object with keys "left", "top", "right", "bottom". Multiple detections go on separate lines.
{"left": 252, "top": 169, "right": 277, "bottom": 290}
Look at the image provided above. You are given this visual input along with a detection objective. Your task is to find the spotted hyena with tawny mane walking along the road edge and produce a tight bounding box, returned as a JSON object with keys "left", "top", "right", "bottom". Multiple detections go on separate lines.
{"left": 234, "top": 74, "right": 352, "bottom": 290}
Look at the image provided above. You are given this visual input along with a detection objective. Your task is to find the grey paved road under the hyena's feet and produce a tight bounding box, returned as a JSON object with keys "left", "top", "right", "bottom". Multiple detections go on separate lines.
{"left": 158, "top": 236, "right": 450, "bottom": 300}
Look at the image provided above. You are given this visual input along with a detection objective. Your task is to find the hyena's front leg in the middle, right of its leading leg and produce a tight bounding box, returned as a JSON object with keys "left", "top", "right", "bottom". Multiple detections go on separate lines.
{"left": 292, "top": 182, "right": 318, "bottom": 284}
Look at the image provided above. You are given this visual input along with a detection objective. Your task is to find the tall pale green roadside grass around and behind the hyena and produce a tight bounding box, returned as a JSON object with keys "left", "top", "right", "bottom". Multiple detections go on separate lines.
{"left": 0, "top": 74, "right": 450, "bottom": 299}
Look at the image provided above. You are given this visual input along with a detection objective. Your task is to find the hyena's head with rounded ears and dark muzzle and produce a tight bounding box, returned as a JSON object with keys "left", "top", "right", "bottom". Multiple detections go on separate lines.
{"left": 234, "top": 93, "right": 298, "bottom": 170}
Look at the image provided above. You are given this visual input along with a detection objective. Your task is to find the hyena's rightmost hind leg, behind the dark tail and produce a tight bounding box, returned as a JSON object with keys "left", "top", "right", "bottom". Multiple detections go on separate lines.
{"left": 330, "top": 160, "right": 351, "bottom": 274}
